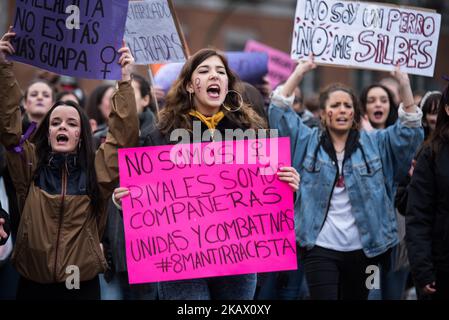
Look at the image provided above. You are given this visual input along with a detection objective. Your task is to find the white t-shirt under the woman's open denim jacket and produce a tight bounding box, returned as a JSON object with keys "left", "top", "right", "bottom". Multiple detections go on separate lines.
{"left": 316, "top": 152, "right": 363, "bottom": 251}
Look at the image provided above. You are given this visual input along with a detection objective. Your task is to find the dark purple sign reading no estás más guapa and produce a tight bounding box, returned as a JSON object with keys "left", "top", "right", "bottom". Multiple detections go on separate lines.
{"left": 11, "top": 0, "right": 128, "bottom": 80}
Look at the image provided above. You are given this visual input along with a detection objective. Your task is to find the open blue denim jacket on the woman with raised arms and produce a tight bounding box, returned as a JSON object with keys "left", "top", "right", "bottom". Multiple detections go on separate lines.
{"left": 269, "top": 99, "right": 424, "bottom": 257}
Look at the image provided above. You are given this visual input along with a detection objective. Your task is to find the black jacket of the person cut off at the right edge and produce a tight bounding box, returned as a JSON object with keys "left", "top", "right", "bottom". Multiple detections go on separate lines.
{"left": 405, "top": 143, "right": 449, "bottom": 288}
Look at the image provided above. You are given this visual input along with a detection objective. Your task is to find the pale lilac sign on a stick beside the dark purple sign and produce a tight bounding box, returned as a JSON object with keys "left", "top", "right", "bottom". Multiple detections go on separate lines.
{"left": 125, "top": 0, "right": 186, "bottom": 64}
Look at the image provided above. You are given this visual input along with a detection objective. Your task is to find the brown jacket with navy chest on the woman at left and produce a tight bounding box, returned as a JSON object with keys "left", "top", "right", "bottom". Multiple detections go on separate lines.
{"left": 0, "top": 64, "right": 138, "bottom": 283}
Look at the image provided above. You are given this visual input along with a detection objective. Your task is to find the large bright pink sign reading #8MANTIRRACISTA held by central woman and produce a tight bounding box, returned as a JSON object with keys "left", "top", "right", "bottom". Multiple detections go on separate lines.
{"left": 119, "top": 138, "right": 297, "bottom": 284}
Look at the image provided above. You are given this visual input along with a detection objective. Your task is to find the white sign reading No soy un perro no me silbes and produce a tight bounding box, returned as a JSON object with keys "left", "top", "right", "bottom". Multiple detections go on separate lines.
{"left": 291, "top": 0, "right": 441, "bottom": 77}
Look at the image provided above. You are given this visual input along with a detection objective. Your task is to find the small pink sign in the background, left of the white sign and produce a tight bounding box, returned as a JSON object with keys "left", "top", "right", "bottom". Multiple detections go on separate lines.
{"left": 245, "top": 40, "right": 295, "bottom": 89}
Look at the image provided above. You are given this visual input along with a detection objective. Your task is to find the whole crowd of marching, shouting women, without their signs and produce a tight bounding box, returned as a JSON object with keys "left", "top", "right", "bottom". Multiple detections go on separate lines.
{"left": 0, "top": 25, "right": 449, "bottom": 300}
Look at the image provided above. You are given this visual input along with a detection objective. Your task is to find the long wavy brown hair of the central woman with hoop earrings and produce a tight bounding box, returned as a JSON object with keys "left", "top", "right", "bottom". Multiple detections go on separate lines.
{"left": 157, "top": 49, "right": 267, "bottom": 134}
